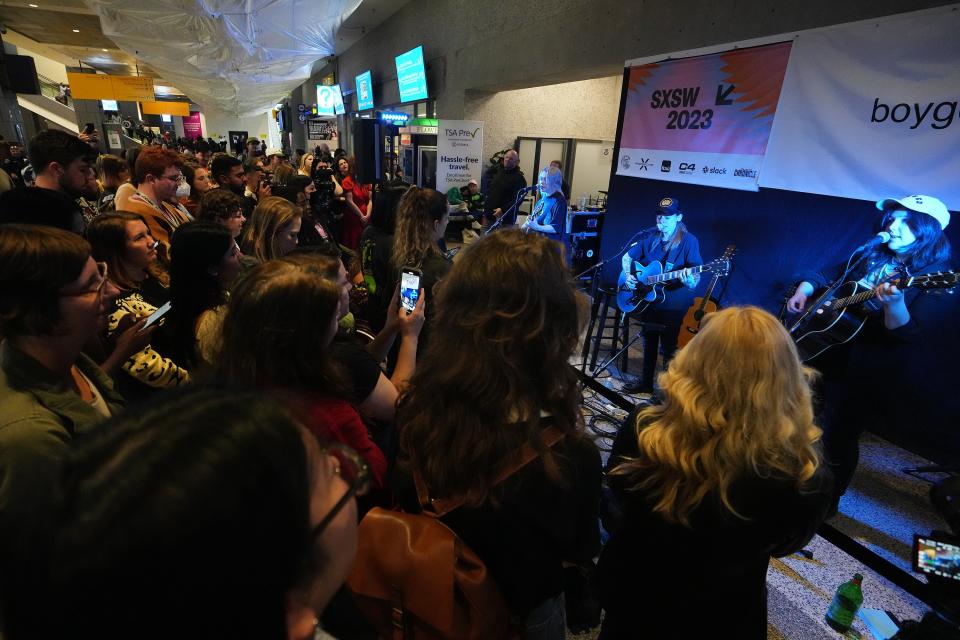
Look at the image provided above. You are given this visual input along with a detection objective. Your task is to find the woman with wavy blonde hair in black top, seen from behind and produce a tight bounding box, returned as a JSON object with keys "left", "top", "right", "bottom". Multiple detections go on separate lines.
{"left": 600, "top": 307, "right": 830, "bottom": 640}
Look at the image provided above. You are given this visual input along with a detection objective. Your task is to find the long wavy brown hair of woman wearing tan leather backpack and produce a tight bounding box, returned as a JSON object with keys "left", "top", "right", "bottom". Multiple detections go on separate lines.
{"left": 396, "top": 230, "right": 582, "bottom": 505}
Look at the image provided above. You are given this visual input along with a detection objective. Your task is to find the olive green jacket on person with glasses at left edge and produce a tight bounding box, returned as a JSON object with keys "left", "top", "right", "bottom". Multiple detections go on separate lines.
{"left": 0, "top": 340, "right": 123, "bottom": 534}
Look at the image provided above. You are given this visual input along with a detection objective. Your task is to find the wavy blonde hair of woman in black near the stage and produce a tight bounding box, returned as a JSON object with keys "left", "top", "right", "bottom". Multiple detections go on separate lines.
{"left": 612, "top": 307, "right": 822, "bottom": 525}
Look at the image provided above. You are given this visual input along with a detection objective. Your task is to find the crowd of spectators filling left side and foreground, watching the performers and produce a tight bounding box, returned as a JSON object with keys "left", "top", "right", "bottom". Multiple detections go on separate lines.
{"left": 0, "top": 131, "right": 829, "bottom": 640}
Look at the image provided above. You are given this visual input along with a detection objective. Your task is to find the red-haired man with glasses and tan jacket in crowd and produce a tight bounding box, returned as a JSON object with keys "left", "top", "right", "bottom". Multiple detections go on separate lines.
{"left": 124, "top": 147, "right": 192, "bottom": 266}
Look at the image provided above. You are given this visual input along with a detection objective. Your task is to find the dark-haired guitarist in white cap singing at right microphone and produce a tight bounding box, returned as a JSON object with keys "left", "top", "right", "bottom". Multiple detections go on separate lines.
{"left": 787, "top": 196, "right": 955, "bottom": 499}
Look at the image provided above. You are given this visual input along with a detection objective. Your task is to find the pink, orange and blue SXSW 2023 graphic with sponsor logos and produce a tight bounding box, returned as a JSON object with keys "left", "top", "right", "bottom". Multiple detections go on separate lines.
{"left": 617, "top": 42, "right": 791, "bottom": 191}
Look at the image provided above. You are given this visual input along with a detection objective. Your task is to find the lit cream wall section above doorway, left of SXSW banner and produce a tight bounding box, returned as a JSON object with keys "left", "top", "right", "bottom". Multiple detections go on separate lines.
{"left": 464, "top": 76, "right": 623, "bottom": 165}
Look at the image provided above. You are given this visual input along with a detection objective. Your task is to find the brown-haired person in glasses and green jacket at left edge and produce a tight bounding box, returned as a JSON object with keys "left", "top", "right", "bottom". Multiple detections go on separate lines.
{"left": 0, "top": 225, "right": 123, "bottom": 544}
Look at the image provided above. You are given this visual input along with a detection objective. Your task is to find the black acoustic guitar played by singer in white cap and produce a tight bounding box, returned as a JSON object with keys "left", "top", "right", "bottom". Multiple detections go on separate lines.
{"left": 789, "top": 271, "right": 960, "bottom": 362}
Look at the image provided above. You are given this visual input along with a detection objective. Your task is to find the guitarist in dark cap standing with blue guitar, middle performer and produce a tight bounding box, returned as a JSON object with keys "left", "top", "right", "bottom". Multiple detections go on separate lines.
{"left": 622, "top": 197, "right": 703, "bottom": 393}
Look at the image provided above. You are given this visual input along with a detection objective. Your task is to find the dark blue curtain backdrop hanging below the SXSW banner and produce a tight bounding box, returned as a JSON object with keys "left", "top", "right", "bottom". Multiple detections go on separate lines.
{"left": 601, "top": 66, "right": 960, "bottom": 462}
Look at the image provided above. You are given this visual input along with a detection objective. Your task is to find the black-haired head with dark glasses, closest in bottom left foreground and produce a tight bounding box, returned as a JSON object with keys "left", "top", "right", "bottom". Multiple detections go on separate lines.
{"left": 7, "top": 389, "right": 368, "bottom": 640}
